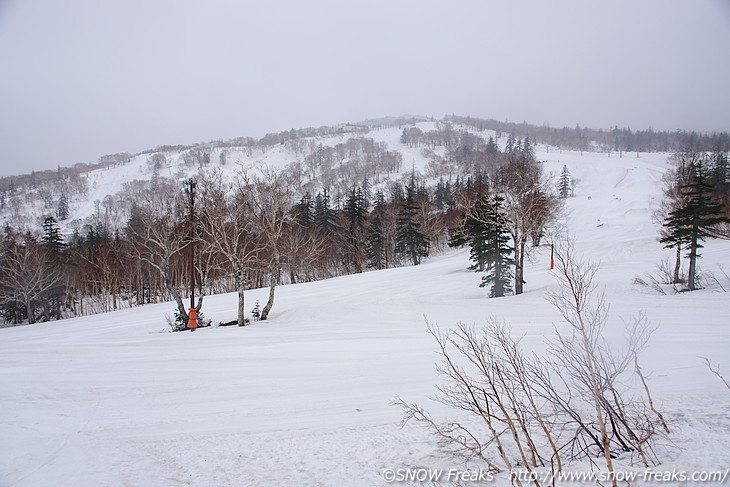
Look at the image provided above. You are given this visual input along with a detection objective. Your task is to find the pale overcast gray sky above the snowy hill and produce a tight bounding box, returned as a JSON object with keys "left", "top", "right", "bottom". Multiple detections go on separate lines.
{"left": 0, "top": 0, "right": 730, "bottom": 175}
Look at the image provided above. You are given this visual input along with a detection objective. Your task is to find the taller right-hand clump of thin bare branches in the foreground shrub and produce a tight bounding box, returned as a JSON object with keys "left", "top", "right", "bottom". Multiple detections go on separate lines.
{"left": 548, "top": 243, "right": 666, "bottom": 478}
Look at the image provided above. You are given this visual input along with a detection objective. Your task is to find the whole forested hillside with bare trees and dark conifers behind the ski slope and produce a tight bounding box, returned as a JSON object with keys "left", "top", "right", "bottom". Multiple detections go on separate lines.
{"left": 0, "top": 116, "right": 728, "bottom": 325}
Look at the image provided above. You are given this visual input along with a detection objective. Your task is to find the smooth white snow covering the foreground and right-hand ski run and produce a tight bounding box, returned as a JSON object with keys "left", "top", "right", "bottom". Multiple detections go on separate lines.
{"left": 0, "top": 131, "right": 730, "bottom": 487}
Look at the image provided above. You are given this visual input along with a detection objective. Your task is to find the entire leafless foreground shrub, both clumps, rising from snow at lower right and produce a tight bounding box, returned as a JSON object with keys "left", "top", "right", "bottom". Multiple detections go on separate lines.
{"left": 396, "top": 245, "right": 669, "bottom": 486}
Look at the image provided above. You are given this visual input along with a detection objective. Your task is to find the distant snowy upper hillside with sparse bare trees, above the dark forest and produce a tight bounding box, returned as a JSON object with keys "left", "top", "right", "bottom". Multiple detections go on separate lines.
{"left": 0, "top": 122, "right": 452, "bottom": 234}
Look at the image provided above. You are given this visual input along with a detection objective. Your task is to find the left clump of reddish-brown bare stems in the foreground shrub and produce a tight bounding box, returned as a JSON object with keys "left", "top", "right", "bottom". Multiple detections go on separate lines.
{"left": 395, "top": 322, "right": 544, "bottom": 486}
